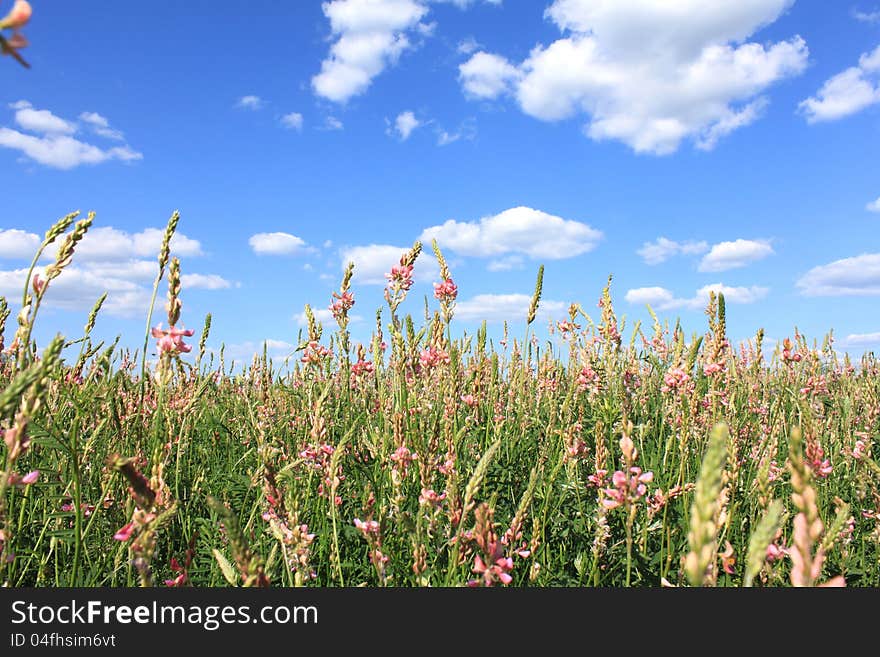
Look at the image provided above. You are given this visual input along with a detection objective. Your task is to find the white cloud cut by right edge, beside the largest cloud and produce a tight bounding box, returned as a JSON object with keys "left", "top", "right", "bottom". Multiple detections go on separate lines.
{"left": 798, "top": 46, "right": 880, "bottom": 123}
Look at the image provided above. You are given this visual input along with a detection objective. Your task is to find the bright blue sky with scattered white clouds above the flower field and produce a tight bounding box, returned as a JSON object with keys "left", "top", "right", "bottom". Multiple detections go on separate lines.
{"left": 0, "top": 0, "right": 880, "bottom": 364}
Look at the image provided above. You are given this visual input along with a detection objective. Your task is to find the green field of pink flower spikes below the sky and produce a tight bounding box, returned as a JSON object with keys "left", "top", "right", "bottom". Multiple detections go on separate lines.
{"left": 0, "top": 213, "right": 880, "bottom": 587}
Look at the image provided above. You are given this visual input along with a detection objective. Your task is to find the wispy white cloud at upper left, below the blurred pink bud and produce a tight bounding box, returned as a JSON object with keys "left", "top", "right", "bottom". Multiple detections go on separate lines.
{"left": 0, "top": 100, "right": 143, "bottom": 169}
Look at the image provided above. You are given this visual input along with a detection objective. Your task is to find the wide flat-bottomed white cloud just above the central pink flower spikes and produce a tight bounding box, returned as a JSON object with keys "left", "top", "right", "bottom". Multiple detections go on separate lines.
{"left": 419, "top": 207, "right": 602, "bottom": 260}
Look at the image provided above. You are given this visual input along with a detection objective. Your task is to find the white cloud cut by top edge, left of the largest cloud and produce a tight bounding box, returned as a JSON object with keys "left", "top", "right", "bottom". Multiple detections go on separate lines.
{"left": 312, "top": 0, "right": 428, "bottom": 103}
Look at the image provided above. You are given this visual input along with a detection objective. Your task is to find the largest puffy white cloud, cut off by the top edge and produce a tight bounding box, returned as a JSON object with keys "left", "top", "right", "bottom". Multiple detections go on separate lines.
{"left": 460, "top": 0, "right": 808, "bottom": 155}
